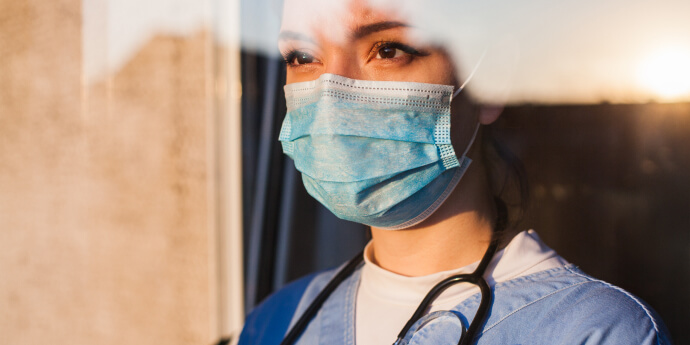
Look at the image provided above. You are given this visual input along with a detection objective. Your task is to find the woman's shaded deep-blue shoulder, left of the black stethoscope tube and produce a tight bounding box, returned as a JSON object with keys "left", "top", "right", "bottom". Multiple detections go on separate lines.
{"left": 239, "top": 274, "right": 318, "bottom": 345}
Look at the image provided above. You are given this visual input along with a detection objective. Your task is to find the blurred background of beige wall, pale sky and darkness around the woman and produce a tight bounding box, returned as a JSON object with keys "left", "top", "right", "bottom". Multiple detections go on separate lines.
{"left": 0, "top": 0, "right": 690, "bottom": 345}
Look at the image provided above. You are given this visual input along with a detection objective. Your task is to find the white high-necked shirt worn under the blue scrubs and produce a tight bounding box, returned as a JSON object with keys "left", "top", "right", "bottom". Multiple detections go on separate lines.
{"left": 355, "top": 230, "right": 567, "bottom": 345}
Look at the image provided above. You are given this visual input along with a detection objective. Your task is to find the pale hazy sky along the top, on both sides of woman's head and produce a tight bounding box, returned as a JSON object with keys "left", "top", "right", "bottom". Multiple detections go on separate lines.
{"left": 83, "top": 0, "right": 690, "bottom": 103}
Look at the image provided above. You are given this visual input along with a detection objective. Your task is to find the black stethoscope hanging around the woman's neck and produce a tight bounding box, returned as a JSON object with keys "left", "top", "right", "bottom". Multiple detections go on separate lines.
{"left": 280, "top": 198, "right": 507, "bottom": 345}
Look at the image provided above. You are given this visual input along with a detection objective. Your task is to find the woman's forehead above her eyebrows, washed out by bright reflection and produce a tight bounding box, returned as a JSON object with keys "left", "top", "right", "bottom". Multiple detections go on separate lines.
{"left": 281, "top": 0, "right": 408, "bottom": 41}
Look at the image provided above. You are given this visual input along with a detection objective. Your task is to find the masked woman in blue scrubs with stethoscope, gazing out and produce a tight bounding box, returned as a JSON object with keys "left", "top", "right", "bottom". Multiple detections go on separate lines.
{"left": 240, "top": 0, "right": 670, "bottom": 345}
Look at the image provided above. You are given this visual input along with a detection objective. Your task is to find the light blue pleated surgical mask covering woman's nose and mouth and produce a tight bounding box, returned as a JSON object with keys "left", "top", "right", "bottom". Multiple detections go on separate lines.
{"left": 279, "top": 74, "right": 479, "bottom": 230}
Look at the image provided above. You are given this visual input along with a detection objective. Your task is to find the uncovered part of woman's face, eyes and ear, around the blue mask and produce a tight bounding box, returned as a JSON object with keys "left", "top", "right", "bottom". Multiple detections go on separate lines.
{"left": 279, "top": 0, "right": 500, "bottom": 154}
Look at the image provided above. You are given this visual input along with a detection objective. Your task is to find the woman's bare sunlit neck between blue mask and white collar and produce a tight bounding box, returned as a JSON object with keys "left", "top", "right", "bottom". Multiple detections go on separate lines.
{"left": 371, "top": 157, "right": 496, "bottom": 276}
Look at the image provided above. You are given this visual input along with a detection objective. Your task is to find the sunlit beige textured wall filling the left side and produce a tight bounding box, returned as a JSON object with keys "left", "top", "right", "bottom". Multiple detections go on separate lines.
{"left": 0, "top": 0, "right": 217, "bottom": 345}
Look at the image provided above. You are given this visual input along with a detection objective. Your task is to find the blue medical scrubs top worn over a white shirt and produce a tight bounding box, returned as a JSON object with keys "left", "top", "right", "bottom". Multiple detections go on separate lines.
{"left": 239, "top": 265, "right": 671, "bottom": 345}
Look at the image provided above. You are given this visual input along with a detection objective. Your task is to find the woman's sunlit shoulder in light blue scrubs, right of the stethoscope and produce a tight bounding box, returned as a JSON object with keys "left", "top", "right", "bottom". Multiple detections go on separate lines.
{"left": 476, "top": 265, "right": 670, "bottom": 344}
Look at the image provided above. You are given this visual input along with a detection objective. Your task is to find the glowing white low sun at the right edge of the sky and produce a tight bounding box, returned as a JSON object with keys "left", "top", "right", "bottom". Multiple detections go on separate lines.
{"left": 637, "top": 47, "right": 690, "bottom": 101}
